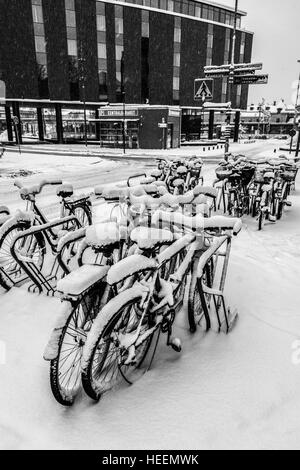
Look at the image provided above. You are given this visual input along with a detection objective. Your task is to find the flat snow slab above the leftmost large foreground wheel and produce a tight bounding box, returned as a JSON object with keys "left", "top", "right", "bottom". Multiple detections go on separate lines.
{"left": 56, "top": 264, "right": 109, "bottom": 297}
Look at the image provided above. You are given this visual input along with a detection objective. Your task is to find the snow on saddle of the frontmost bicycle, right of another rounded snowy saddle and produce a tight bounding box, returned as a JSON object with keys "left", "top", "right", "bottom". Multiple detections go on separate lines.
{"left": 130, "top": 227, "right": 174, "bottom": 250}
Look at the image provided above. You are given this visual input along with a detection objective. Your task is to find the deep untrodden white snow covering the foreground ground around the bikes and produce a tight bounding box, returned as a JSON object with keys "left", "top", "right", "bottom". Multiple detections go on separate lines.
{"left": 0, "top": 144, "right": 300, "bottom": 449}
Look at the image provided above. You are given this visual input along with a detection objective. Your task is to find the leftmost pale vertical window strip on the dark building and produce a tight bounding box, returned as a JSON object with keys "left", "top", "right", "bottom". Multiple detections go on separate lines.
{"left": 31, "top": 0, "right": 50, "bottom": 99}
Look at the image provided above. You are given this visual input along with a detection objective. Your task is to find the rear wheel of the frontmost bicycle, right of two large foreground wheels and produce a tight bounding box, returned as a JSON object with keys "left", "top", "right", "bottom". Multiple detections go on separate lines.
{"left": 81, "top": 291, "right": 155, "bottom": 401}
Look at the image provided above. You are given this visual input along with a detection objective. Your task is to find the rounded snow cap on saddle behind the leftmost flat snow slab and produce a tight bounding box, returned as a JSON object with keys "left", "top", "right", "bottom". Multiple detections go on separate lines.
{"left": 85, "top": 222, "right": 127, "bottom": 248}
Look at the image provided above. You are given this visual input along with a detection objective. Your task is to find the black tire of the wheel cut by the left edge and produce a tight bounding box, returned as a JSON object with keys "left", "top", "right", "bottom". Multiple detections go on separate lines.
{"left": 0, "top": 222, "right": 46, "bottom": 291}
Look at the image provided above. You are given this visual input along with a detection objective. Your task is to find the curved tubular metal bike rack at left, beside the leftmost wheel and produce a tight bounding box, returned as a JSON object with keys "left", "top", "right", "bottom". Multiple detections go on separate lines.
{"left": 11, "top": 216, "right": 84, "bottom": 296}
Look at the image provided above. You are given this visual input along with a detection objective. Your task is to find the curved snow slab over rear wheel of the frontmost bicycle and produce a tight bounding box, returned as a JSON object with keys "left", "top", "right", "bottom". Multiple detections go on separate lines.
{"left": 106, "top": 254, "right": 157, "bottom": 285}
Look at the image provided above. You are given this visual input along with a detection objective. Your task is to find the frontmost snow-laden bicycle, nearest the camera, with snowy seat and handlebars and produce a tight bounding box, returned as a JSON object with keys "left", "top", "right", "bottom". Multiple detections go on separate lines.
{"left": 82, "top": 212, "right": 241, "bottom": 400}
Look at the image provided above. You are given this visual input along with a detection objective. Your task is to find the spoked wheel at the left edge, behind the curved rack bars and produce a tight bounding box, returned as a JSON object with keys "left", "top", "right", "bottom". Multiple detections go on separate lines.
{"left": 0, "top": 222, "right": 46, "bottom": 290}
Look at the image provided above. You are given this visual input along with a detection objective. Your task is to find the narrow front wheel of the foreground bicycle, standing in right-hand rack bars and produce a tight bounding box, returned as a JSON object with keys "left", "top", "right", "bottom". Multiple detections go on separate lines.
{"left": 188, "top": 260, "right": 213, "bottom": 333}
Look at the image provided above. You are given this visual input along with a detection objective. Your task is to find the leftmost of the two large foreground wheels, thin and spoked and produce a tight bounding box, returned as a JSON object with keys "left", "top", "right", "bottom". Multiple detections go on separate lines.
{"left": 50, "top": 283, "right": 105, "bottom": 406}
